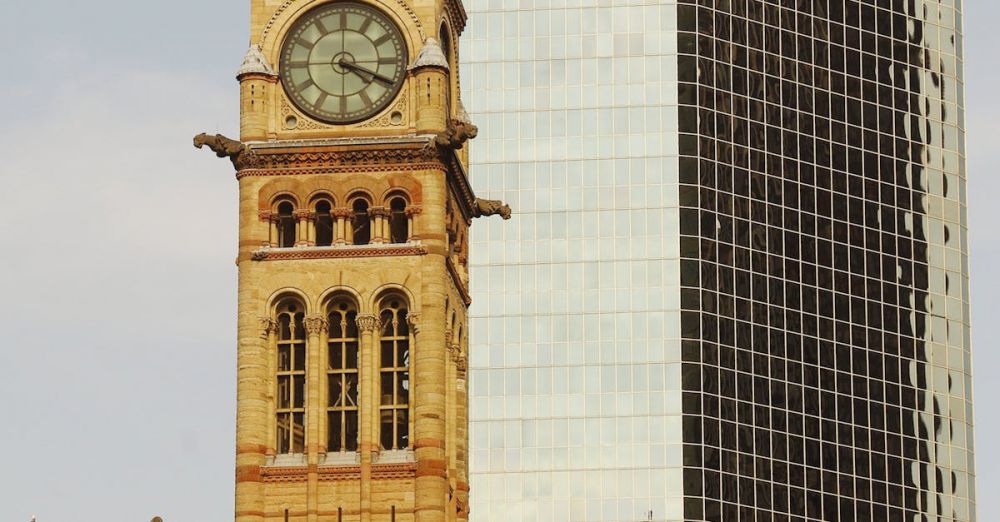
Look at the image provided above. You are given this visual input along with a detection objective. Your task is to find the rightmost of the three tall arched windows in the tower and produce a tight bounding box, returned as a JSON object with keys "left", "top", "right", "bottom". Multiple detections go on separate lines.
{"left": 379, "top": 295, "right": 410, "bottom": 450}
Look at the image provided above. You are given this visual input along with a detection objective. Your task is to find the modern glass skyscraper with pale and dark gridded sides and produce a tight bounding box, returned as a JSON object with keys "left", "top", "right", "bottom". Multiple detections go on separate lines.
{"left": 462, "top": 0, "right": 975, "bottom": 522}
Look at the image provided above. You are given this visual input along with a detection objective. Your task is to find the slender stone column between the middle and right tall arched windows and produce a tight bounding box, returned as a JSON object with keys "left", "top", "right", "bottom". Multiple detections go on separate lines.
{"left": 358, "top": 314, "right": 379, "bottom": 522}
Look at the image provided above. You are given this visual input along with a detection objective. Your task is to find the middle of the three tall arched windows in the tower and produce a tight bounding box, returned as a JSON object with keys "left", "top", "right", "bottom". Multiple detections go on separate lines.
{"left": 326, "top": 297, "right": 358, "bottom": 452}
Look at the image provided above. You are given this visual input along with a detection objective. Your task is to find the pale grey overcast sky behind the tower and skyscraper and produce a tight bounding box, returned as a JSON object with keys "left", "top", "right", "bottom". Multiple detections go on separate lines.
{"left": 0, "top": 0, "right": 1000, "bottom": 522}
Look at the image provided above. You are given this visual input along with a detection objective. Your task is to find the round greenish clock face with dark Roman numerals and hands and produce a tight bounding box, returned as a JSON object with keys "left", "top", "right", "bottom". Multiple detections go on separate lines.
{"left": 279, "top": 2, "right": 406, "bottom": 124}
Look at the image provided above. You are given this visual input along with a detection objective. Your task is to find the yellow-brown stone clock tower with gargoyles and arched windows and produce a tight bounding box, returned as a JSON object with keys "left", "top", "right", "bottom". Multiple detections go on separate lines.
{"left": 195, "top": 0, "right": 510, "bottom": 522}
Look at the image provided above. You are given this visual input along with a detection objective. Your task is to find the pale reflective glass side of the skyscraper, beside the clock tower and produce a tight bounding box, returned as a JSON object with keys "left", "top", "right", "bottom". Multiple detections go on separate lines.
{"left": 461, "top": 0, "right": 683, "bottom": 522}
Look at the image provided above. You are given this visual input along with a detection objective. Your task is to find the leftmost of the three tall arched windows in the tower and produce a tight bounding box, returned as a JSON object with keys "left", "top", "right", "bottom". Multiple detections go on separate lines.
{"left": 275, "top": 298, "right": 306, "bottom": 454}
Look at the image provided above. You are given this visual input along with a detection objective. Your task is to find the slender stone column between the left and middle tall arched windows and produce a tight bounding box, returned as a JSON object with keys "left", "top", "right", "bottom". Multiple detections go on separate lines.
{"left": 305, "top": 315, "right": 326, "bottom": 522}
